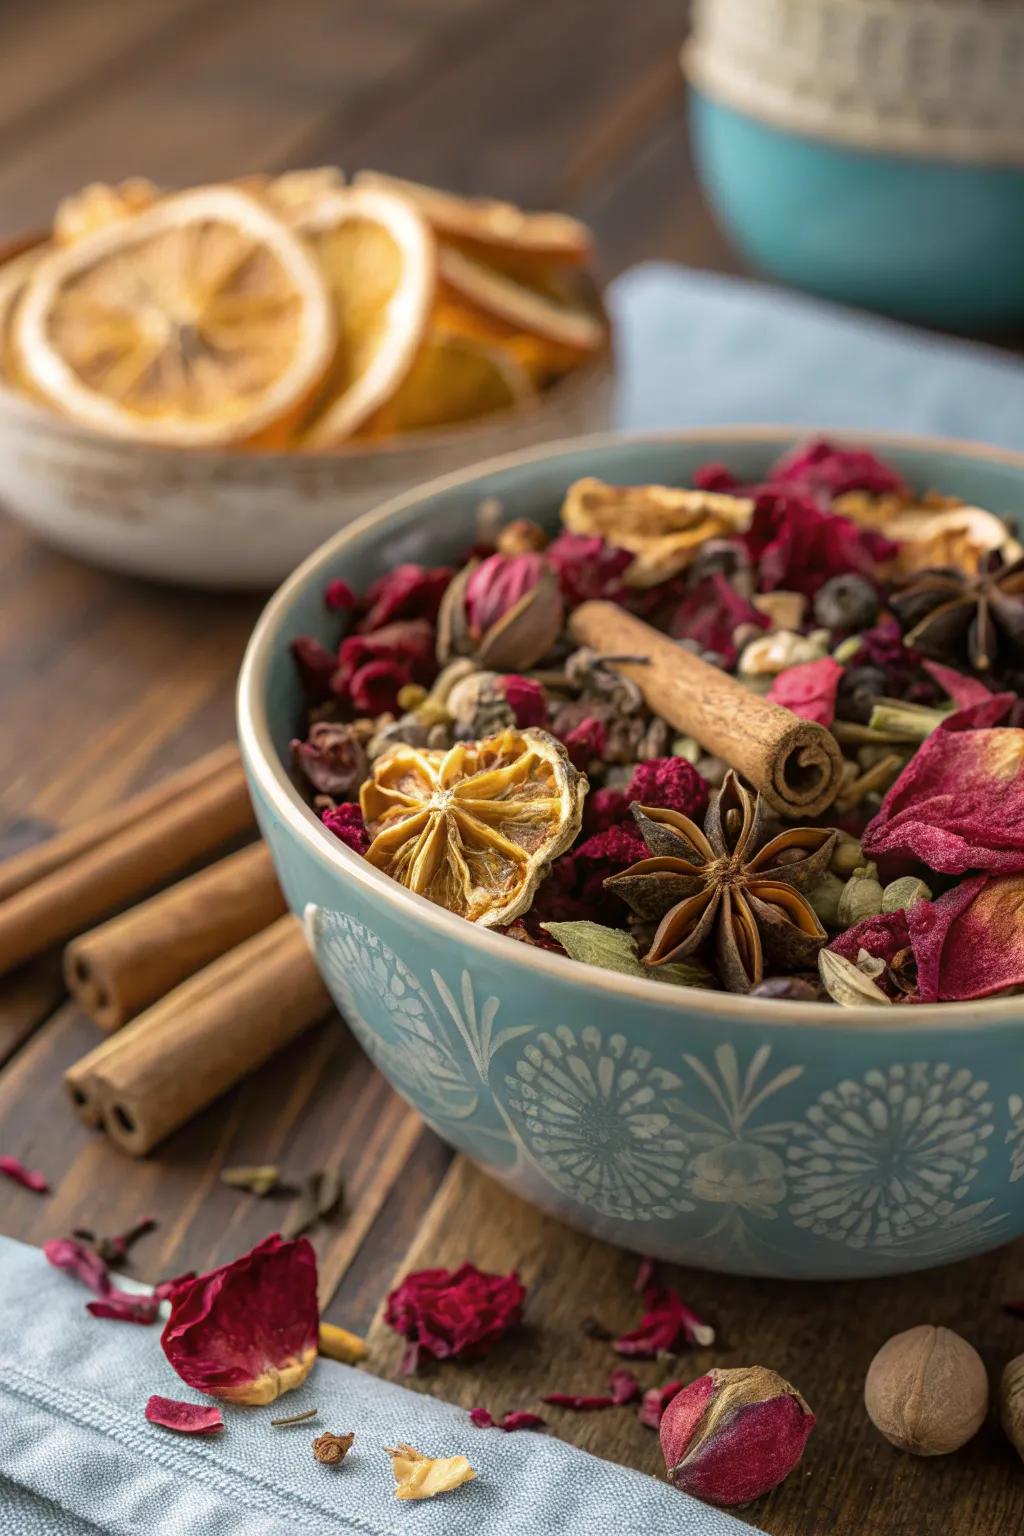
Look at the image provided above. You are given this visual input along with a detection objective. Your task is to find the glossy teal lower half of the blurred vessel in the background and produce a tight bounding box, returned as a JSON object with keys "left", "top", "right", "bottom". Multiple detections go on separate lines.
{"left": 689, "top": 89, "right": 1024, "bottom": 329}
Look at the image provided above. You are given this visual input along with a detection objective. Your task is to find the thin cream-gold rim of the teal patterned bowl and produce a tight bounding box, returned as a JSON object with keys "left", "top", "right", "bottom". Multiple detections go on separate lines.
{"left": 236, "top": 424, "right": 1024, "bottom": 1034}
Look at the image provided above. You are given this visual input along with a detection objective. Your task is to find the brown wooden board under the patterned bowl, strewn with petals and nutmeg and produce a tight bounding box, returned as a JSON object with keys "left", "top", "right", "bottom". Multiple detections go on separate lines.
{"left": 370, "top": 1160, "right": 1024, "bottom": 1536}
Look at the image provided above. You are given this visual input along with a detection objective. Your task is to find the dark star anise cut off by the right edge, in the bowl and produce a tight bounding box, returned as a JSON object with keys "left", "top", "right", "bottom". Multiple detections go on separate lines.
{"left": 889, "top": 550, "right": 1024, "bottom": 671}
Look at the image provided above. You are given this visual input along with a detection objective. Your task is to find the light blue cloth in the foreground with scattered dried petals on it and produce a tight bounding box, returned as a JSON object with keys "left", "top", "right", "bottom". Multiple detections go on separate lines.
{"left": 0, "top": 1238, "right": 749, "bottom": 1536}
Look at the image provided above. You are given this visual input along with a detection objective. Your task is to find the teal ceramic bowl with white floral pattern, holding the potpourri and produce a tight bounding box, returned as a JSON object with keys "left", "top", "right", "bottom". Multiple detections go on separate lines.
{"left": 239, "top": 429, "right": 1024, "bottom": 1278}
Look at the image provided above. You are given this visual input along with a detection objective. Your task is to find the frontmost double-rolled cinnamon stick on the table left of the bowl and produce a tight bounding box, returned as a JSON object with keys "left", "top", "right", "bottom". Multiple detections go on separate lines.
{"left": 72, "top": 915, "right": 330, "bottom": 1157}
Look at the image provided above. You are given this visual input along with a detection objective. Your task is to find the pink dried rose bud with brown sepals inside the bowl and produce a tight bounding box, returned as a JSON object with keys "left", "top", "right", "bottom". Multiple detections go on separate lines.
{"left": 438, "top": 551, "right": 563, "bottom": 673}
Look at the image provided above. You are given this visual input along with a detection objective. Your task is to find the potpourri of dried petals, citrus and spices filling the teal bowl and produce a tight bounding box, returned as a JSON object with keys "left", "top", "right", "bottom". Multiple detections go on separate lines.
{"left": 284, "top": 441, "right": 1024, "bottom": 1006}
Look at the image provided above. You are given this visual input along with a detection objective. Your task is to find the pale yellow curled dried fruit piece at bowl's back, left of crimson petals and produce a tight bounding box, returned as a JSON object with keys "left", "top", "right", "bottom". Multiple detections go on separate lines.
{"left": 562, "top": 478, "right": 754, "bottom": 587}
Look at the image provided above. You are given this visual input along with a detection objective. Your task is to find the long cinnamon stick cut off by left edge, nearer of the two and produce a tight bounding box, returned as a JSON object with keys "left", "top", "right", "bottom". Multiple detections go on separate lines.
{"left": 0, "top": 760, "right": 253, "bottom": 974}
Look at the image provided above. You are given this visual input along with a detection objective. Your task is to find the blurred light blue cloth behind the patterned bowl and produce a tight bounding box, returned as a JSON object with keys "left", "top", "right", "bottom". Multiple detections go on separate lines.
{"left": 609, "top": 263, "right": 1024, "bottom": 449}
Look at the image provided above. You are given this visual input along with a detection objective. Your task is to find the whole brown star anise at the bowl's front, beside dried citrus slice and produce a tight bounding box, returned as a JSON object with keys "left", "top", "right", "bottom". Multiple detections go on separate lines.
{"left": 605, "top": 773, "right": 838, "bottom": 992}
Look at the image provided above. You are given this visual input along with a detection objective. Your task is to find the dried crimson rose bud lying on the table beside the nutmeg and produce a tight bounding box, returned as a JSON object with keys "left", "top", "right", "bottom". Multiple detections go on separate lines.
{"left": 660, "top": 1366, "right": 814, "bottom": 1507}
